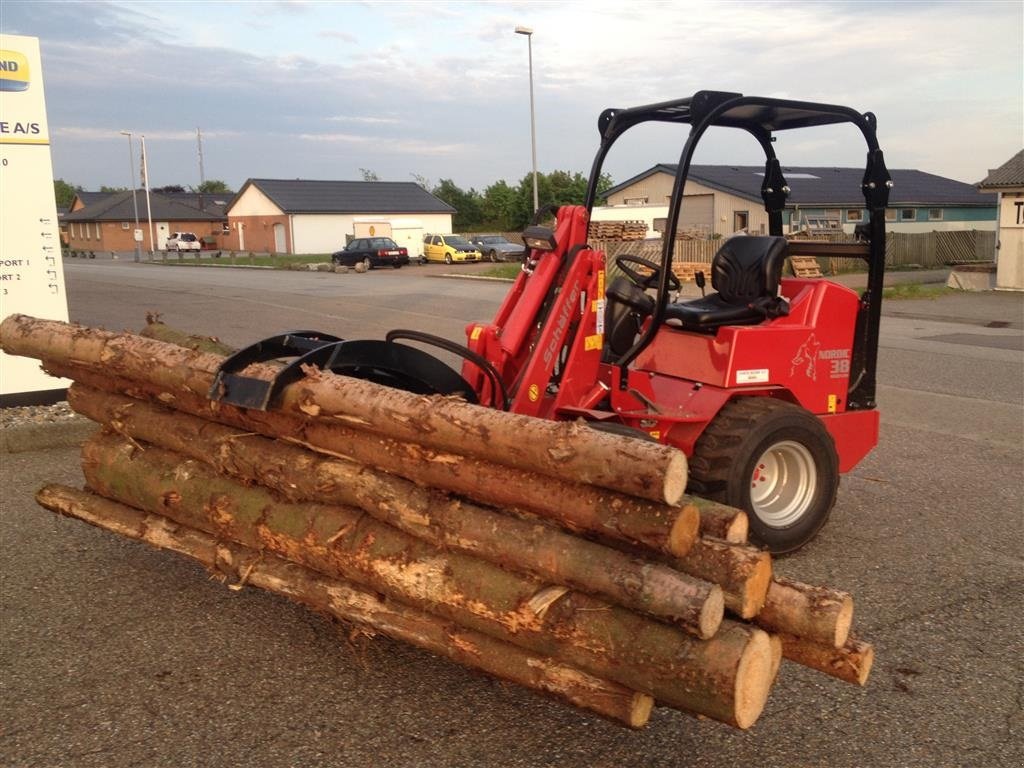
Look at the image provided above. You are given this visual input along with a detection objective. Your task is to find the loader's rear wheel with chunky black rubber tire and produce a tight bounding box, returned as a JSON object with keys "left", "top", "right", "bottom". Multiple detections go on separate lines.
{"left": 687, "top": 397, "right": 839, "bottom": 554}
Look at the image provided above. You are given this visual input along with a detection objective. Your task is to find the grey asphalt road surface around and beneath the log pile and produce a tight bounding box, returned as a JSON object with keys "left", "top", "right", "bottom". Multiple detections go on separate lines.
{"left": 0, "top": 260, "right": 1024, "bottom": 768}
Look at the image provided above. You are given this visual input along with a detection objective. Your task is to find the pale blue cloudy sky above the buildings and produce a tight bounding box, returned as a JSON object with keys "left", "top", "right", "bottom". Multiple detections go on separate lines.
{"left": 0, "top": 0, "right": 1024, "bottom": 189}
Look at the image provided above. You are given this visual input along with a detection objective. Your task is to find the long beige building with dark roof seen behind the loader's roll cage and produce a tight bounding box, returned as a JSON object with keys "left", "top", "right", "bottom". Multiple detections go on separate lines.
{"left": 594, "top": 164, "right": 995, "bottom": 237}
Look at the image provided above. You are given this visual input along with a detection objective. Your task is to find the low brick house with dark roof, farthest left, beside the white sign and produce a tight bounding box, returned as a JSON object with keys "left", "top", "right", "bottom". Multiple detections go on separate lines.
{"left": 61, "top": 189, "right": 226, "bottom": 251}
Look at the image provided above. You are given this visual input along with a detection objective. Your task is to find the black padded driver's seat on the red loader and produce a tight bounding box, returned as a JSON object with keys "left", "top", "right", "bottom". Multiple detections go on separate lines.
{"left": 665, "top": 236, "right": 790, "bottom": 332}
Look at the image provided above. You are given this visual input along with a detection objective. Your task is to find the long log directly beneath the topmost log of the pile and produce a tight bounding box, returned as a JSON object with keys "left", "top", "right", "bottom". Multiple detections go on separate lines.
{"left": 51, "top": 359, "right": 700, "bottom": 555}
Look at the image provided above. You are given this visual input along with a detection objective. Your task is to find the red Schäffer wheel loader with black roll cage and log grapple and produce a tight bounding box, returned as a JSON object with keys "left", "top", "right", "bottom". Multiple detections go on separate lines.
{"left": 213, "top": 91, "right": 892, "bottom": 553}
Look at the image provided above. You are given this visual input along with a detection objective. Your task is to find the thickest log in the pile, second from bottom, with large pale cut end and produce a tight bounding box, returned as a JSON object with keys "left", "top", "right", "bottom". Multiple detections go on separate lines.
{"left": 83, "top": 435, "right": 772, "bottom": 728}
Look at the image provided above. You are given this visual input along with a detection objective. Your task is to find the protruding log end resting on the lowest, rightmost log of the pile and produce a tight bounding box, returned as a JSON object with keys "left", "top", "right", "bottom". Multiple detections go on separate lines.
{"left": 755, "top": 577, "right": 853, "bottom": 648}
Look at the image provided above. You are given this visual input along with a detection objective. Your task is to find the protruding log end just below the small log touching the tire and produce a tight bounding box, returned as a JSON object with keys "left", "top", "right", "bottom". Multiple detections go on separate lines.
{"left": 667, "top": 538, "right": 771, "bottom": 618}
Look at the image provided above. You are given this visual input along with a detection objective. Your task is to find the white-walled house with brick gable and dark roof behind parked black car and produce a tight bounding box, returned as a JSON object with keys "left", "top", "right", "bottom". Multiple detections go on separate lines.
{"left": 224, "top": 178, "right": 456, "bottom": 256}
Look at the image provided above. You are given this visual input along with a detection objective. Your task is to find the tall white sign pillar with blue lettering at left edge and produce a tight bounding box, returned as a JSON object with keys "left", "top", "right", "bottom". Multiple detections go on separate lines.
{"left": 0, "top": 35, "right": 70, "bottom": 407}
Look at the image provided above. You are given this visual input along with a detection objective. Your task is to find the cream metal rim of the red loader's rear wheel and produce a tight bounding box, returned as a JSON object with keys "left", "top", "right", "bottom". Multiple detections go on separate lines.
{"left": 751, "top": 440, "right": 817, "bottom": 528}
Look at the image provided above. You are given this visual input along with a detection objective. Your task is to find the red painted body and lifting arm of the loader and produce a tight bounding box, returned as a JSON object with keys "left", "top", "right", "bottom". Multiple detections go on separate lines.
{"left": 463, "top": 207, "right": 879, "bottom": 479}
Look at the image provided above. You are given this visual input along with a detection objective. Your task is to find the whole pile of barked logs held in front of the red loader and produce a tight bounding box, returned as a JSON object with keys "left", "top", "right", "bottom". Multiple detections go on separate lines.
{"left": 0, "top": 315, "right": 872, "bottom": 728}
